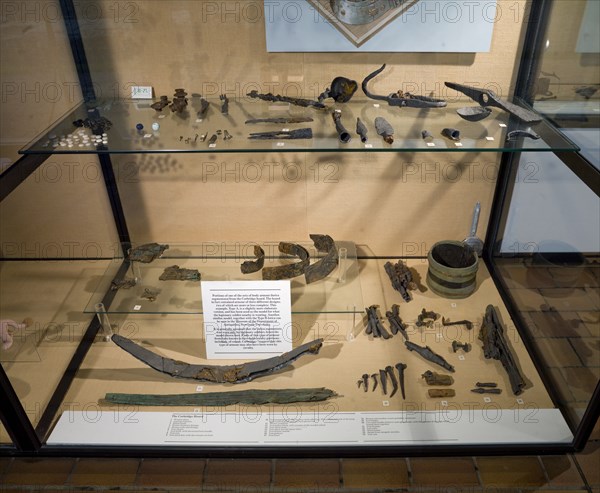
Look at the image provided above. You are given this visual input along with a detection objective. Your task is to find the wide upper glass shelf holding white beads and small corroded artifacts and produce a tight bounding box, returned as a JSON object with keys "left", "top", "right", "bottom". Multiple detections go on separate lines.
{"left": 19, "top": 98, "right": 579, "bottom": 154}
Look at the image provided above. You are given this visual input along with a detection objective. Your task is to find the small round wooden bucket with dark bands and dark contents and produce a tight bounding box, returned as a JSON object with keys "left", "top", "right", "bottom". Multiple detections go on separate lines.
{"left": 427, "top": 241, "right": 479, "bottom": 299}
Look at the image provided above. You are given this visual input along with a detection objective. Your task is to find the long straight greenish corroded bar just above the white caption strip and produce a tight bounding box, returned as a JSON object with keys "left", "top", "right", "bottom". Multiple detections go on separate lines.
{"left": 104, "top": 387, "right": 337, "bottom": 407}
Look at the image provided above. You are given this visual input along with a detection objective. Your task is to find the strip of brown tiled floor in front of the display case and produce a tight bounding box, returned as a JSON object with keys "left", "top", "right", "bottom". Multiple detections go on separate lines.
{"left": 0, "top": 436, "right": 600, "bottom": 493}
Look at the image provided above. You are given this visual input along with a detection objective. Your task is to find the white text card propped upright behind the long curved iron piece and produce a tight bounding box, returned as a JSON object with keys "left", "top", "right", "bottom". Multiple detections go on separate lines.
{"left": 202, "top": 281, "right": 292, "bottom": 359}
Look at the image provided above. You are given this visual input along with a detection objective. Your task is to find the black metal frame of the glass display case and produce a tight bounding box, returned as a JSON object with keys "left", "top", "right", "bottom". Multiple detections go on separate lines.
{"left": 0, "top": 0, "right": 600, "bottom": 458}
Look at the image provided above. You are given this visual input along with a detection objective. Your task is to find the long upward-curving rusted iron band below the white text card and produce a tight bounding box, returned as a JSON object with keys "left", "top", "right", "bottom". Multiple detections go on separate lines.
{"left": 112, "top": 334, "right": 323, "bottom": 383}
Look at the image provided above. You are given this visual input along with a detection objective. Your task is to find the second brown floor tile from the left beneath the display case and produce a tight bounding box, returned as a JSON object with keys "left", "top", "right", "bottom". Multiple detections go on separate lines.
{"left": 69, "top": 459, "right": 140, "bottom": 486}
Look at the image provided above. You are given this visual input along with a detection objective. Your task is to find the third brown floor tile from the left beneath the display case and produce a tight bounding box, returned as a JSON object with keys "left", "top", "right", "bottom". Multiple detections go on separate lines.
{"left": 135, "top": 459, "right": 206, "bottom": 488}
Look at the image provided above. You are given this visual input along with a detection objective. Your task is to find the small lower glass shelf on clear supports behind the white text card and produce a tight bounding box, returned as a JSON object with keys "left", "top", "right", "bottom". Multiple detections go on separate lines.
{"left": 84, "top": 241, "right": 364, "bottom": 314}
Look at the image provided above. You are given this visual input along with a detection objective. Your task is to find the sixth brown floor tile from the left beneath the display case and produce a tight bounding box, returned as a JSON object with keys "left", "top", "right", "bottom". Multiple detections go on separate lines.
{"left": 342, "top": 459, "right": 409, "bottom": 488}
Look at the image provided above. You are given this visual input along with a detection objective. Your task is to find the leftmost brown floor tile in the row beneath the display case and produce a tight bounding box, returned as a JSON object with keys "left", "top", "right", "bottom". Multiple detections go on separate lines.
{"left": 2, "top": 458, "right": 75, "bottom": 486}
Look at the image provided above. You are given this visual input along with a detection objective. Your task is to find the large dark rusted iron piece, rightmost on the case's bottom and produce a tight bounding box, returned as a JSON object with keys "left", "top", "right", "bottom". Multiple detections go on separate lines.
{"left": 479, "top": 305, "right": 526, "bottom": 395}
